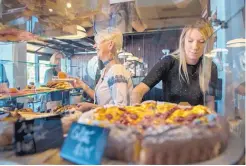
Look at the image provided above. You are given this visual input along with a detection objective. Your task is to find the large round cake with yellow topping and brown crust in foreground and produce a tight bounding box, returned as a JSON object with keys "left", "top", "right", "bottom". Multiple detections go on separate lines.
{"left": 80, "top": 101, "right": 229, "bottom": 165}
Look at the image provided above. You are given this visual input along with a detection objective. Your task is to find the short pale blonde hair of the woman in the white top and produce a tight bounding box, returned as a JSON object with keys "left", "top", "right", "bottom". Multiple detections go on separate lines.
{"left": 95, "top": 27, "right": 123, "bottom": 53}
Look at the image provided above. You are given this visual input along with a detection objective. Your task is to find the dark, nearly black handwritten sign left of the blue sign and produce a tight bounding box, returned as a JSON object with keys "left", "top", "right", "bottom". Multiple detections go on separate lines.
{"left": 14, "top": 115, "right": 64, "bottom": 155}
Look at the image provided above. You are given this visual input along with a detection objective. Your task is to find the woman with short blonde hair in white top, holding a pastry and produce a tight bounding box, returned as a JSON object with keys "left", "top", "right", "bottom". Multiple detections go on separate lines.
{"left": 75, "top": 28, "right": 133, "bottom": 111}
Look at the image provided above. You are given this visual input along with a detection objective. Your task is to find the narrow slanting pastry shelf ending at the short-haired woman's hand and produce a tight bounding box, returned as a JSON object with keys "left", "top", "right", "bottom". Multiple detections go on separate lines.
{"left": 0, "top": 88, "right": 77, "bottom": 100}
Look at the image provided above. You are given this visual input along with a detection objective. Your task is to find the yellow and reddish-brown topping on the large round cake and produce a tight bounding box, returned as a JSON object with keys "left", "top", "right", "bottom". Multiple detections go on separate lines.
{"left": 93, "top": 102, "right": 212, "bottom": 126}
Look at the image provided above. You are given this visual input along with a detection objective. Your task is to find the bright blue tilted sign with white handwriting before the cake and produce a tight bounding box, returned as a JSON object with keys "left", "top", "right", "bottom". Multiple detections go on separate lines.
{"left": 60, "top": 123, "right": 109, "bottom": 165}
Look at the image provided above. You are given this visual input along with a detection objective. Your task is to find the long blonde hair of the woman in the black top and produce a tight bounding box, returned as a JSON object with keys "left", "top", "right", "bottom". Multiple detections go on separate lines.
{"left": 172, "top": 19, "right": 214, "bottom": 93}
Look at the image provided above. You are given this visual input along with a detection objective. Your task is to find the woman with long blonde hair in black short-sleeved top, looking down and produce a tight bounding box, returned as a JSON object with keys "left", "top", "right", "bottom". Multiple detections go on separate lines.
{"left": 131, "top": 19, "right": 217, "bottom": 109}
